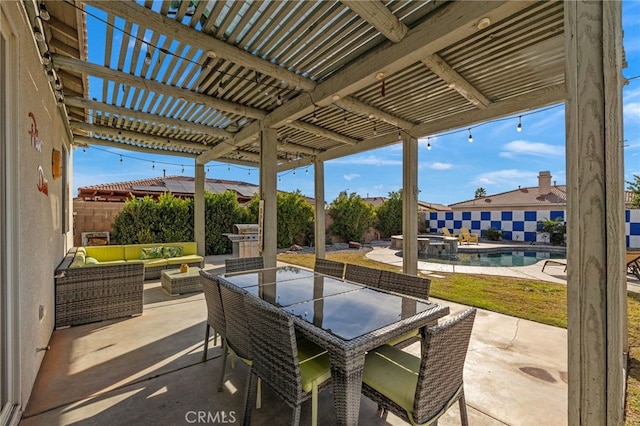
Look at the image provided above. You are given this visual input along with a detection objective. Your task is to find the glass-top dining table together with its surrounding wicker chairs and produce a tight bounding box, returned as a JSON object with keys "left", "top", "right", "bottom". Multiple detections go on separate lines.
{"left": 200, "top": 257, "right": 475, "bottom": 425}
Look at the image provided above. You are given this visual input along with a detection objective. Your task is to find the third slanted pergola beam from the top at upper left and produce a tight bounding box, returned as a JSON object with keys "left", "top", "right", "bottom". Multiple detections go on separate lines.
{"left": 65, "top": 97, "right": 233, "bottom": 138}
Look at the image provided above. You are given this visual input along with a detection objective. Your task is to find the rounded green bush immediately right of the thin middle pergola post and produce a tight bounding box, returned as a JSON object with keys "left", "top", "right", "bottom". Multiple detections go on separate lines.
{"left": 329, "top": 191, "right": 376, "bottom": 241}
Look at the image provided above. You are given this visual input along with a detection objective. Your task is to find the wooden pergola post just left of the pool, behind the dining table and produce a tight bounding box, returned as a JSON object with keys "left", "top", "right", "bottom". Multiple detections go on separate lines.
{"left": 402, "top": 137, "right": 418, "bottom": 275}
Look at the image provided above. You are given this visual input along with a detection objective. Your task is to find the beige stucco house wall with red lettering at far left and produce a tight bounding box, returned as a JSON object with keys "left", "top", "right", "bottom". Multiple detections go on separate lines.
{"left": 2, "top": 2, "right": 72, "bottom": 408}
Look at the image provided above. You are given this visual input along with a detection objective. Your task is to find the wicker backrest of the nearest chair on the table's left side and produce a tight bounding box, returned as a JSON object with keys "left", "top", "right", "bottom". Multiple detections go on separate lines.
{"left": 245, "top": 297, "right": 302, "bottom": 404}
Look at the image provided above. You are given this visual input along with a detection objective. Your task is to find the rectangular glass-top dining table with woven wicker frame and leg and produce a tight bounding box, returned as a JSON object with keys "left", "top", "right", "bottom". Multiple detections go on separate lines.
{"left": 219, "top": 266, "right": 449, "bottom": 425}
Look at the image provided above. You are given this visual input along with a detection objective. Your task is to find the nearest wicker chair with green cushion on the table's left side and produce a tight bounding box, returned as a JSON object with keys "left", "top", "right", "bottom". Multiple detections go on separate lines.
{"left": 243, "top": 298, "right": 331, "bottom": 426}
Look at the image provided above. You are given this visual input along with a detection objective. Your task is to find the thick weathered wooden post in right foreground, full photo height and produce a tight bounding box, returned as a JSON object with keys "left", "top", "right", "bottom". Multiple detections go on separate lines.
{"left": 564, "top": 1, "right": 627, "bottom": 425}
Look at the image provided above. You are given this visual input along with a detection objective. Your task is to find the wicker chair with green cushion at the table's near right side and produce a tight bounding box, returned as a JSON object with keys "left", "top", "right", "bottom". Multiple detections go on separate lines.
{"left": 362, "top": 308, "right": 476, "bottom": 426}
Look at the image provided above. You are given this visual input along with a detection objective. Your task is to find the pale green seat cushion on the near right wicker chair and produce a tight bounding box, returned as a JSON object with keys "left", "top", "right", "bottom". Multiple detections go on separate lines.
{"left": 362, "top": 345, "right": 420, "bottom": 418}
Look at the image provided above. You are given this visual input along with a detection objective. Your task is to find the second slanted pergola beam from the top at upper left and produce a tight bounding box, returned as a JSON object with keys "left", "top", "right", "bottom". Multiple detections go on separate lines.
{"left": 51, "top": 54, "right": 266, "bottom": 120}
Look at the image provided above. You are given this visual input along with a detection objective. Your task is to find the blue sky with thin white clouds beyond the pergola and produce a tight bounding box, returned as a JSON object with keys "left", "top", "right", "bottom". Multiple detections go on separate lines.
{"left": 73, "top": 0, "right": 640, "bottom": 205}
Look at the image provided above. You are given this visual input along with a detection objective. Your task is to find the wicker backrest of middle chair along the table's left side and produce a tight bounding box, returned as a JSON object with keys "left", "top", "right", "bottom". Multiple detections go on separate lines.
{"left": 219, "top": 280, "right": 254, "bottom": 359}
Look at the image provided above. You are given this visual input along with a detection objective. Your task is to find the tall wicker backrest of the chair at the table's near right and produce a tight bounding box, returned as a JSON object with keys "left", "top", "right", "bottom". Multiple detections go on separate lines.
{"left": 413, "top": 308, "right": 476, "bottom": 423}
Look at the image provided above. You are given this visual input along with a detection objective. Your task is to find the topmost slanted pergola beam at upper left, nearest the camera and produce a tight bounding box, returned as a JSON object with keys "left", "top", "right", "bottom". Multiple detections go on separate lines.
{"left": 86, "top": 0, "right": 316, "bottom": 91}
